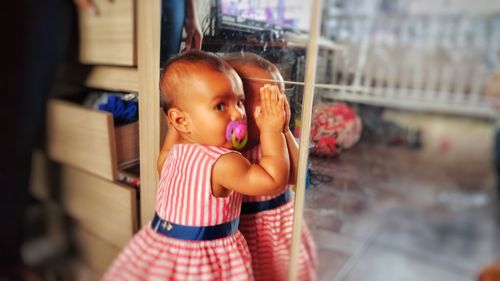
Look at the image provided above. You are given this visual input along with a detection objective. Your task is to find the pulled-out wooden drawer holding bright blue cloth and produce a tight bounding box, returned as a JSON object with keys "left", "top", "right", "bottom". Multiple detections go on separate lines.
{"left": 47, "top": 99, "right": 139, "bottom": 180}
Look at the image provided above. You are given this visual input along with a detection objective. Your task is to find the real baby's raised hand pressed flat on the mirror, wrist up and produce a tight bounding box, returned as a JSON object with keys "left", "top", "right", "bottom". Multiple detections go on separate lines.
{"left": 254, "top": 84, "right": 285, "bottom": 133}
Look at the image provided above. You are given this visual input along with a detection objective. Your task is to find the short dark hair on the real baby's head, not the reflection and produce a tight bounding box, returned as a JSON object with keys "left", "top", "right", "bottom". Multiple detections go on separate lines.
{"left": 160, "top": 50, "right": 237, "bottom": 113}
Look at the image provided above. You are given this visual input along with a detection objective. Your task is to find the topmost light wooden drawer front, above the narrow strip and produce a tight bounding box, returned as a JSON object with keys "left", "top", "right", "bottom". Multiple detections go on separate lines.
{"left": 79, "top": 0, "right": 136, "bottom": 66}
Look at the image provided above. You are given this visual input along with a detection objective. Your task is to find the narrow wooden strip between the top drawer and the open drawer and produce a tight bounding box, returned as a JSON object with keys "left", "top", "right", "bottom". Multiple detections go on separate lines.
{"left": 85, "top": 66, "right": 139, "bottom": 92}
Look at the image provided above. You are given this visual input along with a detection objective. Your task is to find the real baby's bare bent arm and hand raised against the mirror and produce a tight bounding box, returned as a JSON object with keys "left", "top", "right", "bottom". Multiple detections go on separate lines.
{"left": 212, "top": 86, "right": 290, "bottom": 196}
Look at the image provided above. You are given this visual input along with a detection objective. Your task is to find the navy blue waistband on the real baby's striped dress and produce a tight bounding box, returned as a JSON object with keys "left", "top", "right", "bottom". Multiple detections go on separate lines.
{"left": 151, "top": 213, "right": 240, "bottom": 240}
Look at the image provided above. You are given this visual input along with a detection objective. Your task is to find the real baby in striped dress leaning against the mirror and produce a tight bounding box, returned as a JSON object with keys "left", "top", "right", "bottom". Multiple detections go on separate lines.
{"left": 104, "top": 50, "right": 290, "bottom": 280}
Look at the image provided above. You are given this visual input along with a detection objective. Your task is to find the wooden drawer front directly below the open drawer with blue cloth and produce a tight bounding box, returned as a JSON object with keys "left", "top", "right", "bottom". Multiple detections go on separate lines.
{"left": 61, "top": 166, "right": 137, "bottom": 248}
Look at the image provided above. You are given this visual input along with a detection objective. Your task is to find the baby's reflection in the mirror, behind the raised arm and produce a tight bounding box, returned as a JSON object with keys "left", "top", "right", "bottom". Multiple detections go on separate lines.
{"left": 224, "top": 52, "right": 317, "bottom": 281}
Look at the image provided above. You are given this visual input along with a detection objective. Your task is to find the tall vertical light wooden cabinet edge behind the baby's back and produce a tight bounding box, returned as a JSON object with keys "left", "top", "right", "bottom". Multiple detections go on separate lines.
{"left": 137, "top": 0, "right": 161, "bottom": 224}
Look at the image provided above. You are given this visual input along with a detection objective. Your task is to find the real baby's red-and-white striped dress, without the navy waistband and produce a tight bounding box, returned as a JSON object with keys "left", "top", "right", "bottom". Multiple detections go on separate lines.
{"left": 103, "top": 144, "right": 253, "bottom": 281}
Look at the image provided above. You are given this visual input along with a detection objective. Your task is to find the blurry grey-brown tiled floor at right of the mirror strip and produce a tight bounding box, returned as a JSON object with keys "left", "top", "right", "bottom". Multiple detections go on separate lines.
{"left": 305, "top": 143, "right": 500, "bottom": 281}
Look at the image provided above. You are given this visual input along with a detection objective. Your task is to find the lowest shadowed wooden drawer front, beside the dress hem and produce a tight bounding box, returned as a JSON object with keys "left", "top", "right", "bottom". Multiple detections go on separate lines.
{"left": 73, "top": 226, "right": 120, "bottom": 275}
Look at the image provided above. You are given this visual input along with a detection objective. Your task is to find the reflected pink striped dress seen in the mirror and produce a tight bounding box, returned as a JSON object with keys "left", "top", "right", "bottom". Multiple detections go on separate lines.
{"left": 239, "top": 145, "right": 317, "bottom": 281}
